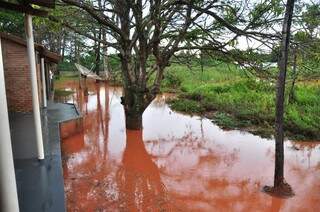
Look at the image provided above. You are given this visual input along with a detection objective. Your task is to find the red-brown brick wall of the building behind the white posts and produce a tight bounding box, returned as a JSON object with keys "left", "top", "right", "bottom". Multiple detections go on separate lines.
{"left": 2, "top": 39, "right": 41, "bottom": 112}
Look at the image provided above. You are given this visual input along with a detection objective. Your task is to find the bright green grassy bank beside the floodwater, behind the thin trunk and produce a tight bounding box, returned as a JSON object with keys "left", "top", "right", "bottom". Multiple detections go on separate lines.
{"left": 162, "top": 64, "right": 320, "bottom": 140}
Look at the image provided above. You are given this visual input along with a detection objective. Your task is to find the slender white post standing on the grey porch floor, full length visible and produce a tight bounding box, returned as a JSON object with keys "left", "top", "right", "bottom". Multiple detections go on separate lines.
{"left": 25, "top": 14, "right": 44, "bottom": 160}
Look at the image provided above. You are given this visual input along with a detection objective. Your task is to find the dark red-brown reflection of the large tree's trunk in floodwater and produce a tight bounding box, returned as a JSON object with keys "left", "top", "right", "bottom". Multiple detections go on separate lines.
{"left": 117, "top": 130, "right": 169, "bottom": 211}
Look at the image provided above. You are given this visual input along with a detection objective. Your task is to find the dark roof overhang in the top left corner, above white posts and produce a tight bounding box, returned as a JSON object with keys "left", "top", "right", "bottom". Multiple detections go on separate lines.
{"left": 0, "top": 0, "right": 55, "bottom": 16}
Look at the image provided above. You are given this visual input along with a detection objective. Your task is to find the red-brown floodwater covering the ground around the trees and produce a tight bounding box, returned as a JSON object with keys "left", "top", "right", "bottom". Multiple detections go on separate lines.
{"left": 58, "top": 81, "right": 320, "bottom": 212}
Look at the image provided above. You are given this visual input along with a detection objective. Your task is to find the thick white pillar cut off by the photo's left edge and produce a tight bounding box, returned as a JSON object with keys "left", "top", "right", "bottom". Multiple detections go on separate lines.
{"left": 0, "top": 38, "right": 19, "bottom": 212}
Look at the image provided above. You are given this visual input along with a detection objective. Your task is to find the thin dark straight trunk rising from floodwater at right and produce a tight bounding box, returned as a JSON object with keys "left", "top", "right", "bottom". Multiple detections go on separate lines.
{"left": 274, "top": 0, "right": 294, "bottom": 195}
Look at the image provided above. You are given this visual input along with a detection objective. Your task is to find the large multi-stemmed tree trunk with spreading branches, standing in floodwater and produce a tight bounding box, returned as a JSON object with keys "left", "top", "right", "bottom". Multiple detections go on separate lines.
{"left": 63, "top": 0, "right": 200, "bottom": 132}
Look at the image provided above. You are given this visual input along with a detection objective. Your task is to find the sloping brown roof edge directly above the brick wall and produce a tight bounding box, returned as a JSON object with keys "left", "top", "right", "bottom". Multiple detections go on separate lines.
{"left": 0, "top": 32, "right": 61, "bottom": 63}
